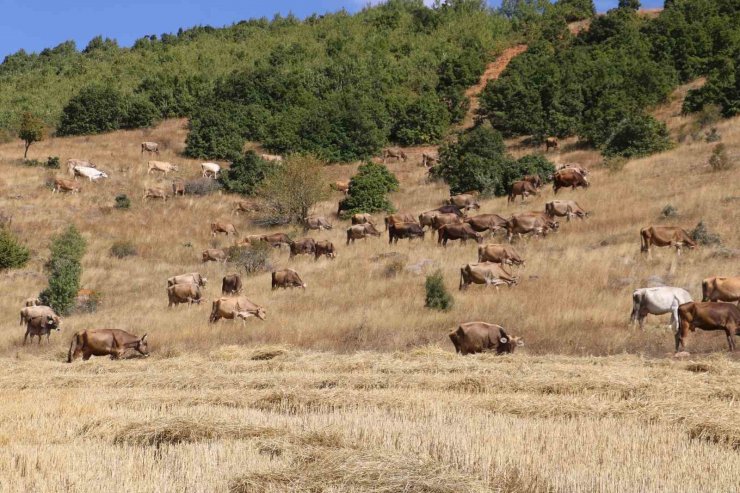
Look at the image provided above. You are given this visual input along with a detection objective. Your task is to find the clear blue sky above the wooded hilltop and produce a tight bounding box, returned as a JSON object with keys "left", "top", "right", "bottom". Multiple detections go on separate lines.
{"left": 0, "top": 0, "right": 663, "bottom": 60}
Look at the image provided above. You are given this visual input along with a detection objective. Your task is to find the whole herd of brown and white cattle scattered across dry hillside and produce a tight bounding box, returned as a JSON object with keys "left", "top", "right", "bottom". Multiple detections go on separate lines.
{"left": 14, "top": 141, "right": 740, "bottom": 362}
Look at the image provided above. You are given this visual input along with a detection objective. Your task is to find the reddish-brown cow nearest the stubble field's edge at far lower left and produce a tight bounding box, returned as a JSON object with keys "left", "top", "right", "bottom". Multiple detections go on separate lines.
{"left": 67, "top": 329, "right": 149, "bottom": 363}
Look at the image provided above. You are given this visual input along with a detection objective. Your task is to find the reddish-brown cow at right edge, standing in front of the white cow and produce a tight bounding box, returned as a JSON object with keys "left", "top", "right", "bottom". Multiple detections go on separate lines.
{"left": 676, "top": 301, "right": 740, "bottom": 351}
